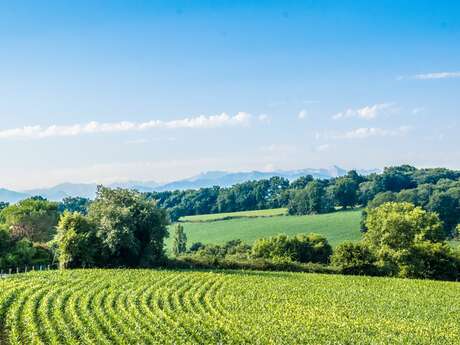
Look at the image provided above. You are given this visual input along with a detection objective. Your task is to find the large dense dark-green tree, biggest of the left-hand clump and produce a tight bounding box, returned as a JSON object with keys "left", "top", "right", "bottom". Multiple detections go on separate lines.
{"left": 88, "top": 186, "right": 168, "bottom": 267}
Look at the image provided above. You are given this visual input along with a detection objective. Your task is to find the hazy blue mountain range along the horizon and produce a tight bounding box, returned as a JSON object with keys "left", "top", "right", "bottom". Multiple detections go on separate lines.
{"left": 0, "top": 166, "right": 379, "bottom": 203}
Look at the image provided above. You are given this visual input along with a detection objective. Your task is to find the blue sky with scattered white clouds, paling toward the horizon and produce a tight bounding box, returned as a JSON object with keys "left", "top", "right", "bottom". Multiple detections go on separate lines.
{"left": 0, "top": 0, "right": 460, "bottom": 190}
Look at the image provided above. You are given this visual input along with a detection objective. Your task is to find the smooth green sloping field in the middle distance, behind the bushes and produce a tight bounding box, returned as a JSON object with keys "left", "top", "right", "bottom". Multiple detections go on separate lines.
{"left": 166, "top": 210, "right": 361, "bottom": 248}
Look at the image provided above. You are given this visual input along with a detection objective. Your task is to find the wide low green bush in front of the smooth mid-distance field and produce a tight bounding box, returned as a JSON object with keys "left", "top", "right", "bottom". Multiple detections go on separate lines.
{"left": 252, "top": 234, "right": 332, "bottom": 263}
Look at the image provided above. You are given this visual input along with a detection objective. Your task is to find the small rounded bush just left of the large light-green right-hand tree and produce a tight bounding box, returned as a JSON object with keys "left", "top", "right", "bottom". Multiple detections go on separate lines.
{"left": 331, "top": 242, "right": 379, "bottom": 275}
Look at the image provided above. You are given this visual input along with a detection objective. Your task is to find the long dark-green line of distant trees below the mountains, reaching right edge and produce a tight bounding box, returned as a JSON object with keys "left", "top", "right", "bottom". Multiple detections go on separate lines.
{"left": 147, "top": 165, "right": 460, "bottom": 237}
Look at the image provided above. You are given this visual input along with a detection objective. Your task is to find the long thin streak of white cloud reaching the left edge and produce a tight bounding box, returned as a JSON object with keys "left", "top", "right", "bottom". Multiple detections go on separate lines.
{"left": 0, "top": 112, "right": 252, "bottom": 139}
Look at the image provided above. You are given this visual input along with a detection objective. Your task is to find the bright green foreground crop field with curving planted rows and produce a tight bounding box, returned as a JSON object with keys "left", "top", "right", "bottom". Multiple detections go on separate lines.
{"left": 0, "top": 270, "right": 460, "bottom": 345}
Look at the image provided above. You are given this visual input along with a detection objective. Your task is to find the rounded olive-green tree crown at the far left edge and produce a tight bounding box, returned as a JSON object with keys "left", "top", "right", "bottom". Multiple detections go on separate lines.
{"left": 0, "top": 198, "right": 59, "bottom": 242}
